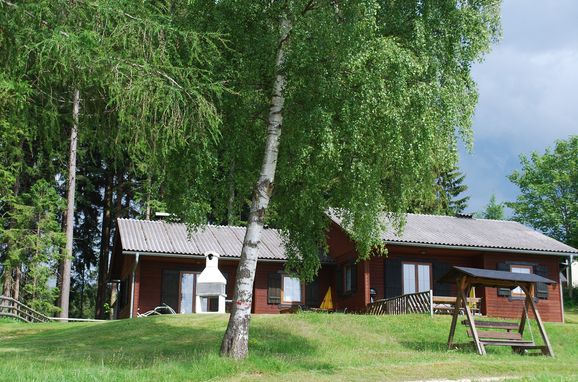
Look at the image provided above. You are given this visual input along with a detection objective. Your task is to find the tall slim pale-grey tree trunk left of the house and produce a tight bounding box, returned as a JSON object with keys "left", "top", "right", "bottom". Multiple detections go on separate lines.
{"left": 60, "top": 89, "right": 80, "bottom": 318}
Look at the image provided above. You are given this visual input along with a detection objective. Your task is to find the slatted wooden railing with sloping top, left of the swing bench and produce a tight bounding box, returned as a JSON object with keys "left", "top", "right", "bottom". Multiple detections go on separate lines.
{"left": 366, "top": 290, "right": 433, "bottom": 315}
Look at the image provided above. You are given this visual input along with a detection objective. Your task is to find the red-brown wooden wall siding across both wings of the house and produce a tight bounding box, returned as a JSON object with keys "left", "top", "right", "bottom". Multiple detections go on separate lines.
{"left": 113, "top": 223, "right": 562, "bottom": 321}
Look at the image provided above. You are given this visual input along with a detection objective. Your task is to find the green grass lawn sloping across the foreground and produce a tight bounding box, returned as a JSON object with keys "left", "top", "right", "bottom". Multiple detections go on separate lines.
{"left": 0, "top": 312, "right": 578, "bottom": 382}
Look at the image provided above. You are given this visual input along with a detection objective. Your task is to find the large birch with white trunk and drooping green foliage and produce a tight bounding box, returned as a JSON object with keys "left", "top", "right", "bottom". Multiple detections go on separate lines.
{"left": 182, "top": 0, "right": 499, "bottom": 359}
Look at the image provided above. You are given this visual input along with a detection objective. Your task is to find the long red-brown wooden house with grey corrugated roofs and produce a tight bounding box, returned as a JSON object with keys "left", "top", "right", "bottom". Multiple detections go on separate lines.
{"left": 111, "top": 213, "right": 578, "bottom": 321}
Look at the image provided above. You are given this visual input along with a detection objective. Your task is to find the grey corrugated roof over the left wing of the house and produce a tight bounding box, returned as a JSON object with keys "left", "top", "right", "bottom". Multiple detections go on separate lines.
{"left": 117, "top": 219, "right": 286, "bottom": 260}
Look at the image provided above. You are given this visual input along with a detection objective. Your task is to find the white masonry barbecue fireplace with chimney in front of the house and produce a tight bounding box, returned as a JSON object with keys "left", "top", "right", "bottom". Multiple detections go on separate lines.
{"left": 195, "top": 252, "right": 227, "bottom": 313}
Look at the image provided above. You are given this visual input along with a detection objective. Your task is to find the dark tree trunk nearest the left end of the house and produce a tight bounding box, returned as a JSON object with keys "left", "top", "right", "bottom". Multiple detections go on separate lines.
{"left": 95, "top": 169, "right": 113, "bottom": 319}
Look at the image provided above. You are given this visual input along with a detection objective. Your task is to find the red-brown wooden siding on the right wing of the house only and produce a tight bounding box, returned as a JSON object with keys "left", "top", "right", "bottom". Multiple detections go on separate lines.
{"left": 328, "top": 223, "right": 562, "bottom": 322}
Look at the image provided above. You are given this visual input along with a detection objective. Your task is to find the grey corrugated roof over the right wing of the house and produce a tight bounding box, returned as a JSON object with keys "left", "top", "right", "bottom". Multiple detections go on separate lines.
{"left": 328, "top": 211, "right": 578, "bottom": 254}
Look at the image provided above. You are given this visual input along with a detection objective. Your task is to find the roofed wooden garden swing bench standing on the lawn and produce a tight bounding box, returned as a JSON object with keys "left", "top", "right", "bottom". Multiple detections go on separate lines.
{"left": 440, "top": 267, "right": 555, "bottom": 357}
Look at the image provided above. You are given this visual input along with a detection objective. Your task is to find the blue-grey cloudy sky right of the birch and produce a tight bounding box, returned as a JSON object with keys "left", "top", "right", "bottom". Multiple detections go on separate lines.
{"left": 460, "top": 0, "right": 578, "bottom": 214}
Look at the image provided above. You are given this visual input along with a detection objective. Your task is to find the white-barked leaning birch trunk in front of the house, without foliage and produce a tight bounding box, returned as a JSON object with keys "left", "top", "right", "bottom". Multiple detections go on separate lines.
{"left": 221, "top": 14, "right": 292, "bottom": 359}
